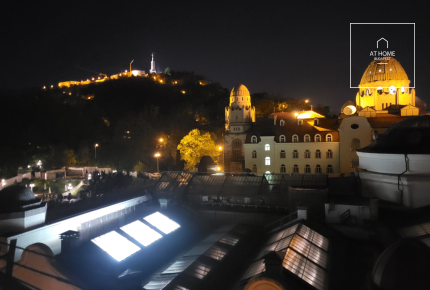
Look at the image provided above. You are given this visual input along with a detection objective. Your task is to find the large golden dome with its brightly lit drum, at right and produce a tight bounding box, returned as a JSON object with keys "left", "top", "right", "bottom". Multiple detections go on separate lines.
{"left": 356, "top": 57, "right": 415, "bottom": 113}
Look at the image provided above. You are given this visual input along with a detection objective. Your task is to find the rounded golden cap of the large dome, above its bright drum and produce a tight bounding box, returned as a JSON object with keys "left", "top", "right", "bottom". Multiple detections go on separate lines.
{"left": 359, "top": 57, "right": 409, "bottom": 87}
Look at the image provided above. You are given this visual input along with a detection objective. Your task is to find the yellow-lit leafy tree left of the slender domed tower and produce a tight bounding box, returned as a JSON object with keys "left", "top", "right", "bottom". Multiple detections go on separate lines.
{"left": 177, "top": 129, "right": 219, "bottom": 171}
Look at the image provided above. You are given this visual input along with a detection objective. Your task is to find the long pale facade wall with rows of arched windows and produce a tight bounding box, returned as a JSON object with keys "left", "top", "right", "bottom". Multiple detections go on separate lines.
{"left": 244, "top": 136, "right": 340, "bottom": 175}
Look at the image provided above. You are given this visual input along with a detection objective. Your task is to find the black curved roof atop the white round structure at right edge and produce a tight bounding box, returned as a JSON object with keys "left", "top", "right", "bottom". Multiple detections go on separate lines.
{"left": 358, "top": 115, "right": 430, "bottom": 154}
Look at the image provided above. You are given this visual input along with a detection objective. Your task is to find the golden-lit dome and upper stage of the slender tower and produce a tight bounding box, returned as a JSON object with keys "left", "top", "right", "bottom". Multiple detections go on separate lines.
{"left": 225, "top": 84, "right": 255, "bottom": 133}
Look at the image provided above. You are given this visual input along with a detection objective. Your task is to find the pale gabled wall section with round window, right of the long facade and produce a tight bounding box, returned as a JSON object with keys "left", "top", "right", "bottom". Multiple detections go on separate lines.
{"left": 339, "top": 116, "right": 373, "bottom": 175}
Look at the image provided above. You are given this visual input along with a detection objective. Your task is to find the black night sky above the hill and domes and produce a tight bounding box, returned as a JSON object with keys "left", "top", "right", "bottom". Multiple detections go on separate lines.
{"left": 0, "top": 0, "right": 430, "bottom": 111}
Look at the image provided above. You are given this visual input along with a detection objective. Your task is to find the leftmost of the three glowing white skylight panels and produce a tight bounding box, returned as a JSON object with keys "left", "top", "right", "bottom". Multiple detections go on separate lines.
{"left": 91, "top": 231, "right": 140, "bottom": 262}
